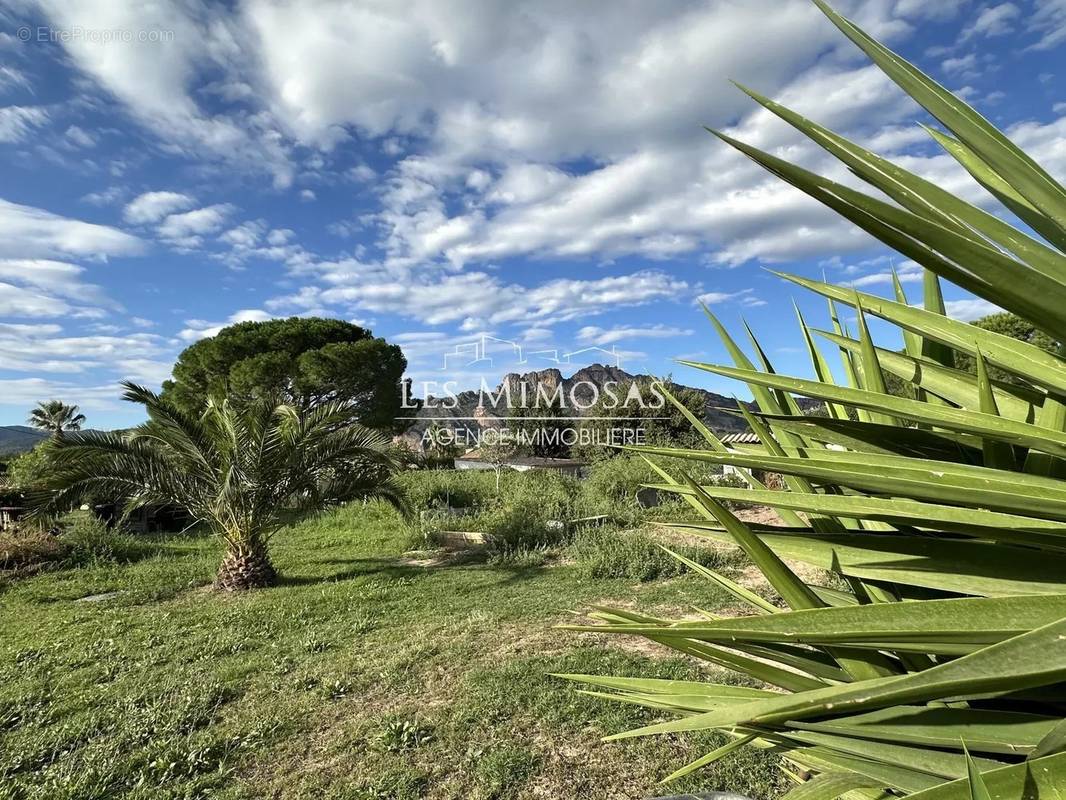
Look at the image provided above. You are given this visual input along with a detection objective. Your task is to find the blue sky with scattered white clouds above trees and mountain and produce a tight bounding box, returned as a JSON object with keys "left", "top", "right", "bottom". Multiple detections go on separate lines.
{"left": 0, "top": 0, "right": 1066, "bottom": 428}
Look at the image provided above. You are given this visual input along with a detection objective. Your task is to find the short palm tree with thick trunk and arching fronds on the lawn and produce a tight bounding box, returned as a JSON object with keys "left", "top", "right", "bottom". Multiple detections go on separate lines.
{"left": 35, "top": 383, "right": 403, "bottom": 591}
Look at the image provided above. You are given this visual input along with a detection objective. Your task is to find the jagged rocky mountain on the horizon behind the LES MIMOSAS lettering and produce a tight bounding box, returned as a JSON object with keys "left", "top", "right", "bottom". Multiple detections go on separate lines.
{"left": 403, "top": 364, "right": 747, "bottom": 443}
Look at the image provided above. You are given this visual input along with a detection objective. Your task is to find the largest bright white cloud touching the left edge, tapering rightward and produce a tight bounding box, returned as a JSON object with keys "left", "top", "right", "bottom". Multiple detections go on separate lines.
{"left": 0, "top": 199, "right": 144, "bottom": 258}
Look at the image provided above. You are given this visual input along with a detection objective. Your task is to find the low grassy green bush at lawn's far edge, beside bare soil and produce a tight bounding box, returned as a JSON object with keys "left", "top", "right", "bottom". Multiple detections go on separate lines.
{"left": 569, "top": 528, "right": 727, "bottom": 581}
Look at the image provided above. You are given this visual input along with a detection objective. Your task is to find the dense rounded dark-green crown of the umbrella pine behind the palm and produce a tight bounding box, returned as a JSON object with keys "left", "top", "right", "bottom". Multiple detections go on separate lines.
{"left": 163, "top": 317, "right": 413, "bottom": 430}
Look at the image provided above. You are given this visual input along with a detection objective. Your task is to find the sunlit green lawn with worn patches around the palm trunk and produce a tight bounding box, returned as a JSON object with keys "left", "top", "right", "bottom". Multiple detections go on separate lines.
{"left": 0, "top": 508, "right": 781, "bottom": 800}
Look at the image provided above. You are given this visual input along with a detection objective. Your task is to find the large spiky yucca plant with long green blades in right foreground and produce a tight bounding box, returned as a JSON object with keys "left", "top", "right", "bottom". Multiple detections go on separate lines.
{"left": 565, "top": 0, "right": 1066, "bottom": 800}
